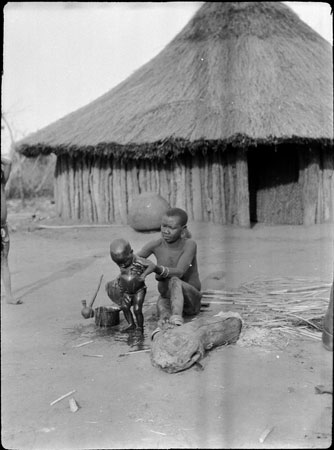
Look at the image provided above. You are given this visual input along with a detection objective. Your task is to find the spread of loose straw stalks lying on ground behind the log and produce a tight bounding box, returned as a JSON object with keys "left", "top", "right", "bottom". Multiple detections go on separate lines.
{"left": 203, "top": 277, "right": 331, "bottom": 340}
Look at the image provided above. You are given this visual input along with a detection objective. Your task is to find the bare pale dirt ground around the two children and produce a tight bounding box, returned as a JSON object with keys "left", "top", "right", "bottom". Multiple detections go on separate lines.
{"left": 1, "top": 202, "right": 334, "bottom": 450}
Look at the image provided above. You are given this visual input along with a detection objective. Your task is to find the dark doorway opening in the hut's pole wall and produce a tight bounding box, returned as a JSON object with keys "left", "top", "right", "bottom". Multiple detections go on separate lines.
{"left": 247, "top": 147, "right": 303, "bottom": 225}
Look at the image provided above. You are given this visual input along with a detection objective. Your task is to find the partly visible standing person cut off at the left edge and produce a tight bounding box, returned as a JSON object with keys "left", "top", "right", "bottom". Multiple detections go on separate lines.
{"left": 1, "top": 156, "right": 22, "bottom": 305}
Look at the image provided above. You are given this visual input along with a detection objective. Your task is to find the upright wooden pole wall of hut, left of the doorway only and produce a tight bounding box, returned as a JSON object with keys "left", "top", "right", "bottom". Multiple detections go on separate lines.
{"left": 55, "top": 153, "right": 246, "bottom": 224}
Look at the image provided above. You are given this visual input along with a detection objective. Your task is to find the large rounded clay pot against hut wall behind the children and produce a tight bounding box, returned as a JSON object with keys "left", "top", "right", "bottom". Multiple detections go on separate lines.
{"left": 128, "top": 192, "right": 170, "bottom": 231}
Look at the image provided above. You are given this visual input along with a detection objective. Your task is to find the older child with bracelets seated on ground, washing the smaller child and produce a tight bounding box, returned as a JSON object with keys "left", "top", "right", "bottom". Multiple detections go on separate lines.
{"left": 137, "top": 208, "right": 202, "bottom": 326}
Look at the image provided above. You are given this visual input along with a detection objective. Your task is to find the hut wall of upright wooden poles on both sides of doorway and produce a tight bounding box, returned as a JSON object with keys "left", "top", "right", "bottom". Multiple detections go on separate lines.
{"left": 55, "top": 149, "right": 334, "bottom": 226}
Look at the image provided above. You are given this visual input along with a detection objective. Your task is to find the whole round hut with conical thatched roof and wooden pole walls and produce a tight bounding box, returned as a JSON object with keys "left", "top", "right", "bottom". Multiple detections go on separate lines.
{"left": 19, "top": 2, "right": 334, "bottom": 224}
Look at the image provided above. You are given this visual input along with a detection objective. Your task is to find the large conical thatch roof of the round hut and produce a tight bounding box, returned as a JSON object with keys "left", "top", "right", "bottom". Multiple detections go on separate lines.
{"left": 20, "top": 2, "right": 333, "bottom": 156}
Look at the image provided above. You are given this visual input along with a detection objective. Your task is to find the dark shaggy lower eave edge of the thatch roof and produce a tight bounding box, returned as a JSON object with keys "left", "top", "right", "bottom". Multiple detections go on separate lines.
{"left": 19, "top": 134, "right": 334, "bottom": 162}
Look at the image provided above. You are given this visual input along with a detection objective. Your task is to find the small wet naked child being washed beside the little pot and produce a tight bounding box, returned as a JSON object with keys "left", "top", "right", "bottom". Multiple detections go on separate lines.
{"left": 106, "top": 239, "right": 155, "bottom": 333}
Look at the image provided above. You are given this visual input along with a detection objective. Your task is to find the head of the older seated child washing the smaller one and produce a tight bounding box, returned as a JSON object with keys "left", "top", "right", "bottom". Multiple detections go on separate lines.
{"left": 161, "top": 208, "right": 190, "bottom": 243}
